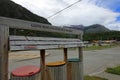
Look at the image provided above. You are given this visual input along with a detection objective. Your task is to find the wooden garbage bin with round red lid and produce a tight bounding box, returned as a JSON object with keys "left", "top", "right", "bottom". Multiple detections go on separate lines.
{"left": 10, "top": 65, "right": 40, "bottom": 80}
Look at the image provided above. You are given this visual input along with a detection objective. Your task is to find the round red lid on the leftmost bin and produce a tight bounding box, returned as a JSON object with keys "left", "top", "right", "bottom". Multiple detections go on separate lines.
{"left": 12, "top": 65, "right": 40, "bottom": 77}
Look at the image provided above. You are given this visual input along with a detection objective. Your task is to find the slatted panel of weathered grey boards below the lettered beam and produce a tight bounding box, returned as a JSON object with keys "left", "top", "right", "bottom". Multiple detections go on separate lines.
{"left": 10, "top": 36, "right": 83, "bottom": 50}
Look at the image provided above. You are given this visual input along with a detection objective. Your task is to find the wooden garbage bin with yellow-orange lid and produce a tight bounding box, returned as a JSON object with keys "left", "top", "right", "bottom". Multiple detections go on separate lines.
{"left": 46, "top": 61, "right": 67, "bottom": 80}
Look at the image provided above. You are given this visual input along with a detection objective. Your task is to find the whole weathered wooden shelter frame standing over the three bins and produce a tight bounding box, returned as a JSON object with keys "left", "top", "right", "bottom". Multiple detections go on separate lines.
{"left": 0, "top": 17, "right": 83, "bottom": 80}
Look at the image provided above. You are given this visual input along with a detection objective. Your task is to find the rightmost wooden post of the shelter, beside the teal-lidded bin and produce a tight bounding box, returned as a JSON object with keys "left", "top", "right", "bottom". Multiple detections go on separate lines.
{"left": 78, "top": 34, "right": 84, "bottom": 80}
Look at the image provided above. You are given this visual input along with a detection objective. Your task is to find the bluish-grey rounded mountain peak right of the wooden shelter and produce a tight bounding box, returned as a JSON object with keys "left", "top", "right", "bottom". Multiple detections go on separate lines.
{"left": 84, "top": 24, "right": 110, "bottom": 33}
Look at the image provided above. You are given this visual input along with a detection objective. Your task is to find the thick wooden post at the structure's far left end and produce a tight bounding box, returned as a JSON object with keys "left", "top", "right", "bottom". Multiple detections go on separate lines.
{"left": 0, "top": 24, "right": 9, "bottom": 80}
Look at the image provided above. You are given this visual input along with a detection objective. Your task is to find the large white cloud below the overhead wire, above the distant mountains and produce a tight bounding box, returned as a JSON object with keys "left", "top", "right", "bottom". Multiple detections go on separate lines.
{"left": 49, "top": 2, "right": 119, "bottom": 25}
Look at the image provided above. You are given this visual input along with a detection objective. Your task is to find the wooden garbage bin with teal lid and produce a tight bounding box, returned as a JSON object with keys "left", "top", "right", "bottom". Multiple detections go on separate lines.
{"left": 67, "top": 58, "right": 81, "bottom": 80}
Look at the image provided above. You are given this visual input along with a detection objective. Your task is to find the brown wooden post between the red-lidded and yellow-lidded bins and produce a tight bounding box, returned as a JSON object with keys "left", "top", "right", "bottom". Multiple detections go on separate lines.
{"left": 40, "top": 50, "right": 46, "bottom": 80}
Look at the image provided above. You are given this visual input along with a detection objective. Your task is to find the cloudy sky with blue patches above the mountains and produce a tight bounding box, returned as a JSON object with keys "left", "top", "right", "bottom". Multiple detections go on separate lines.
{"left": 12, "top": 0, "right": 120, "bottom": 30}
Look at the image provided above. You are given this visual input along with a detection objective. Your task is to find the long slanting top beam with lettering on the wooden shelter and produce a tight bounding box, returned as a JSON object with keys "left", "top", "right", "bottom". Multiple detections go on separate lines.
{"left": 0, "top": 17, "right": 83, "bottom": 35}
